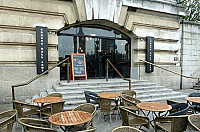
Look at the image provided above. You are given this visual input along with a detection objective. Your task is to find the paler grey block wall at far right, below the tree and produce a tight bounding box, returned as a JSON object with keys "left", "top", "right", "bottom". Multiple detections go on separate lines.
{"left": 181, "top": 21, "right": 200, "bottom": 89}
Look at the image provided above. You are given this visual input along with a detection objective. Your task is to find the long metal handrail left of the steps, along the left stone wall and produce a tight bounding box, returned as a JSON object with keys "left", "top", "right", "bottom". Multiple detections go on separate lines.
{"left": 11, "top": 57, "right": 69, "bottom": 109}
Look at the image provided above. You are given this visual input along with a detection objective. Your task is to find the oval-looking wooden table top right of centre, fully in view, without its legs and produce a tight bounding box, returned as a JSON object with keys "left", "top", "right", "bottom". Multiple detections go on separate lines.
{"left": 136, "top": 102, "right": 172, "bottom": 112}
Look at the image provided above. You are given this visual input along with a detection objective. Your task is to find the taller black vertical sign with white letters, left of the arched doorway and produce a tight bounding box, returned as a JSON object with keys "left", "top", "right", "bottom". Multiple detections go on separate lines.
{"left": 36, "top": 26, "right": 48, "bottom": 74}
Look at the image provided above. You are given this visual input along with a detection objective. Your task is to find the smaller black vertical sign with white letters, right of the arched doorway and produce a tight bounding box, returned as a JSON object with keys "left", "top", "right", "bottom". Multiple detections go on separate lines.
{"left": 146, "top": 37, "right": 154, "bottom": 73}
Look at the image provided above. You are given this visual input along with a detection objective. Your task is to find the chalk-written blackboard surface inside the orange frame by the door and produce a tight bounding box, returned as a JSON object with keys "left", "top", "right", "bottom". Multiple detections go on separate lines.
{"left": 72, "top": 54, "right": 86, "bottom": 76}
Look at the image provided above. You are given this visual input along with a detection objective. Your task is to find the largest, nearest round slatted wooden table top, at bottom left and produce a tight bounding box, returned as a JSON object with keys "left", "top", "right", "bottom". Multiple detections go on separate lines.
{"left": 49, "top": 111, "right": 92, "bottom": 126}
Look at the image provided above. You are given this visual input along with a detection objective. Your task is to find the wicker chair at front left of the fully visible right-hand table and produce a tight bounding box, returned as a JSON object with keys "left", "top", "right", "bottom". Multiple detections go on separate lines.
{"left": 119, "top": 106, "right": 150, "bottom": 129}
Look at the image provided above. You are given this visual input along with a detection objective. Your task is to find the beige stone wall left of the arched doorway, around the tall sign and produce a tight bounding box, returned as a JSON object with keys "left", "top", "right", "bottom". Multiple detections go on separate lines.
{"left": 0, "top": 0, "right": 76, "bottom": 103}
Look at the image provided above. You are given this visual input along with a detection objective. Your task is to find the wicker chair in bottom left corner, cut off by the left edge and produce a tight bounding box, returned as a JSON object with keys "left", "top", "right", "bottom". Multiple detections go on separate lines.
{"left": 0, "top": 110, "right": 17, "bottom": 132}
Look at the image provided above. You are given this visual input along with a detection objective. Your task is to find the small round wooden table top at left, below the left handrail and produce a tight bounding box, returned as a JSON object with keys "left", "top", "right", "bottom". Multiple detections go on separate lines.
{"left": 33, "top": 97, "right": 62, "bottom": 103}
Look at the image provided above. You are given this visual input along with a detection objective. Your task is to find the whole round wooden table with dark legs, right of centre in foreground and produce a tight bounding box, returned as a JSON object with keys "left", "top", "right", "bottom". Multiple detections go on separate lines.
{"left": 136, "top": 102, "right": 172, "bottom": 127}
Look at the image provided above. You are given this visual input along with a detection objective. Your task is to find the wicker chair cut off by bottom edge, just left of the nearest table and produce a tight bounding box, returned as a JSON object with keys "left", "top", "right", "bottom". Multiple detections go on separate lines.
{"left": 18, "top": 118, "right": 57, "bottom": 132}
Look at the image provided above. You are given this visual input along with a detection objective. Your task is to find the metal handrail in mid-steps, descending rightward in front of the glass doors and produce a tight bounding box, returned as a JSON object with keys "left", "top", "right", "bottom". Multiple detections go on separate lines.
{"left": 106, "top": 59, "right": 131, "bottom": 90}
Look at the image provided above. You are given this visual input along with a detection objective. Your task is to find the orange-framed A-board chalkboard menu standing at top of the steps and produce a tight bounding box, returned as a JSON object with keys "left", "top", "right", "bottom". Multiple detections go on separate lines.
{"left": 71, "top": 53, "right": 87, "bottom": 81}
